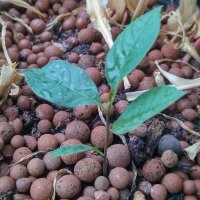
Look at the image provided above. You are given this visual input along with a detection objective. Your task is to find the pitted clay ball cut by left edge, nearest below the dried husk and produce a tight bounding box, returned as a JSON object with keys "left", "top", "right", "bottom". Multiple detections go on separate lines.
{"left": 0, "top": 122, "right": 15, "bottom": 142}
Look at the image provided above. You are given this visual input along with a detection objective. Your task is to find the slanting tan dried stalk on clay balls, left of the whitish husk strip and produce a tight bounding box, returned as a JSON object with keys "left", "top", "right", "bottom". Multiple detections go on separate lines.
{"left": 46, "top": 7, "right": 85, "bottom": 30}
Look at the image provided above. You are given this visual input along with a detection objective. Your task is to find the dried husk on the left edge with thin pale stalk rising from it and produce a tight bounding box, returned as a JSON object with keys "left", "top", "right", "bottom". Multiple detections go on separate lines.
{"left": 0, "top": 17, "right": 22, "bottom": 106}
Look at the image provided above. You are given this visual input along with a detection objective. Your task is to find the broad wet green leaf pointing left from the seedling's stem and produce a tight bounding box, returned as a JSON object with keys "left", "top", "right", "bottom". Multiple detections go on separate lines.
{"left": 21, "top": 60, "right": 100, "bottom": 107}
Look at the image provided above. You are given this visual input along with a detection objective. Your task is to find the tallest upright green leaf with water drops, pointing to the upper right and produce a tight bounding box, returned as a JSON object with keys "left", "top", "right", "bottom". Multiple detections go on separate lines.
{"left": 106, "top": 7, "right": 161, "bottom": 92}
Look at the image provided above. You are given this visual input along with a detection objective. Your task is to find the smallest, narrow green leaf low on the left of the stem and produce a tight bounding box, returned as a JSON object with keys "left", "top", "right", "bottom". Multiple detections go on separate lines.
{"left": 51, "top": 144, "right": 93, "bottom": 157}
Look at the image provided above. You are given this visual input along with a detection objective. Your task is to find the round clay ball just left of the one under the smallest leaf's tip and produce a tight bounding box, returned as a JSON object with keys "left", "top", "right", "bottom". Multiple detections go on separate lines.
{"left": 27, "top": 158, "right": 45, "bottom": 177}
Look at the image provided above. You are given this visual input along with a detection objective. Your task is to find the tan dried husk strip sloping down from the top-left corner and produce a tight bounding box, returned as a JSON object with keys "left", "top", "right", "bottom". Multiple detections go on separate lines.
{"left": 0, "top": 0, "right": 45, "bottom": 17}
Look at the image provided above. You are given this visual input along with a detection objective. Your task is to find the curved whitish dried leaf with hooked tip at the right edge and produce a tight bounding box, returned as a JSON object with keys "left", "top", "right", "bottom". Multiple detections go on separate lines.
{"left": 155, "top": 60, "right": 200, "bottom": 87}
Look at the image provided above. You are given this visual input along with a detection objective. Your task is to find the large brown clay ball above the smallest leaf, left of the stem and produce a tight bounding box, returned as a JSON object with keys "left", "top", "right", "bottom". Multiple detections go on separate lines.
{"left": 65, "top": 120, "right": 90, "bottom": 142}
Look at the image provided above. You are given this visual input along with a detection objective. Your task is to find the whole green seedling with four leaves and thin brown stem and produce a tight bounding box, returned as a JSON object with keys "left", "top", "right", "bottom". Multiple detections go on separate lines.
{"left": 22, "top": 7, "right": 185, "bottom": 175}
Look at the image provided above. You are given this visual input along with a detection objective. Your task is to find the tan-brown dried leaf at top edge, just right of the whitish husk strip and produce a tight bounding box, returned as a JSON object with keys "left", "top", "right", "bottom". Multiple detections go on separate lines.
{"left": 108, "top": 0, "right": 126, "bottom": 22}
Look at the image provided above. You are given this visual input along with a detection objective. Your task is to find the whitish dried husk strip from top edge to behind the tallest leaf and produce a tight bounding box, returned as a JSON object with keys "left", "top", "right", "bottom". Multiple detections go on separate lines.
{"left": 86, "top": 0, "right": 113, "bottom": 48}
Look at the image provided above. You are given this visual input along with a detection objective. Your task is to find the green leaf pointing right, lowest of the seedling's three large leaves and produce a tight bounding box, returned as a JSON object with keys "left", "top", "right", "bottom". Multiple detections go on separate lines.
{"left": 112, "top": 86, "right": 186, "bottom": 134}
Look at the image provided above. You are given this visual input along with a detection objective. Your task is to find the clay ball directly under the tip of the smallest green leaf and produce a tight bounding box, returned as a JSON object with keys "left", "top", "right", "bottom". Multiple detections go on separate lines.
{"left": 43, "top": 152, "right": 61, "bottom": 171}
